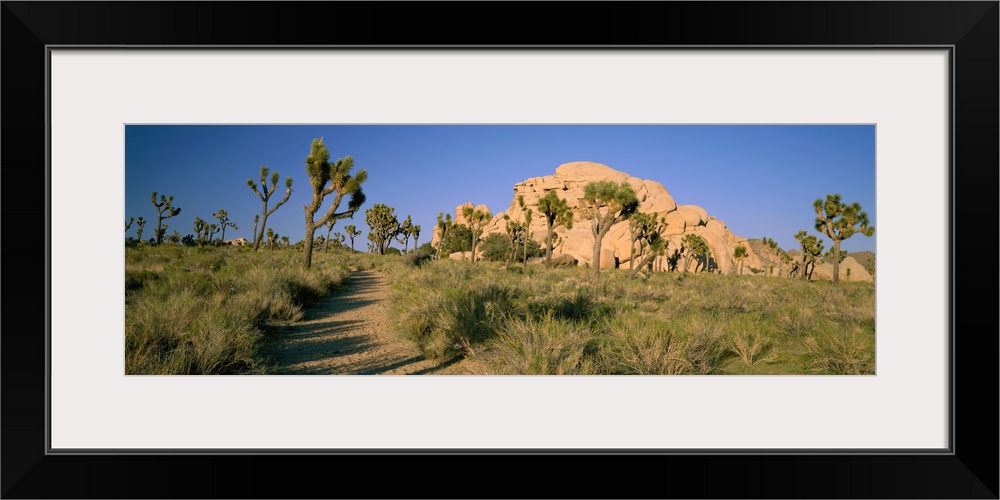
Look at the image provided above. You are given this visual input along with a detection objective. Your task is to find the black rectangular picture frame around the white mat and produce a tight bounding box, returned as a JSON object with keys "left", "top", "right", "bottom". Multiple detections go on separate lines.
{"left": 0, "top": 1, "right": 1000, "bottom": 498}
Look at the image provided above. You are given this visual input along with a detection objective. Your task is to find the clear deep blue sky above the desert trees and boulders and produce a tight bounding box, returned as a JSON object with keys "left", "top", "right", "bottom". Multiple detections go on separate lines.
{"left": 125, "top": 125, "right": 878, "bottom": 252}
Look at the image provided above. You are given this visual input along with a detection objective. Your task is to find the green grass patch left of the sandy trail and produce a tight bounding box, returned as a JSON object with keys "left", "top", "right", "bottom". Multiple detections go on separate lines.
{"left": 125, "top": 245, "right": 354, "bottom": 375}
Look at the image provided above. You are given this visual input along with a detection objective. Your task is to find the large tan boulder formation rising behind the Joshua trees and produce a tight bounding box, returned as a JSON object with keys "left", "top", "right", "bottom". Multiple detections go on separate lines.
{"left": 432, "top": 162, "right": 772, "bottom": 278}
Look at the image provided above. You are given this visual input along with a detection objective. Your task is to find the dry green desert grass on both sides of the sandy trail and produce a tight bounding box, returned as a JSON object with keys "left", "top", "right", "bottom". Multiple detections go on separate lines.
{"left": 124, "top": 245, "right": 875, "bottom": 375}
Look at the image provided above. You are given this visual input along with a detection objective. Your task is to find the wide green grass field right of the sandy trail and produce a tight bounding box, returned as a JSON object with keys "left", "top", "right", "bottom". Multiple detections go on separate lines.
{"left": 391, "top": 260, "right": 875, "bottom": 375}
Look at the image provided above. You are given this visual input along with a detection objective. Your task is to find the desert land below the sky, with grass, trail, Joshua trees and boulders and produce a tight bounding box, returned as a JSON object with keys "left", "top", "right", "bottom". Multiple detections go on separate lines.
{"left": 124, "top": 124, "right": 876, "bottom": 375}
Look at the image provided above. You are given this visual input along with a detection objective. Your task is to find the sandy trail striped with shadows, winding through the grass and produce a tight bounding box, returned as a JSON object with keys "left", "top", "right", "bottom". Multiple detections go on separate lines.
{"left": 272, "top": 271, "right": 450, "bottom": 375}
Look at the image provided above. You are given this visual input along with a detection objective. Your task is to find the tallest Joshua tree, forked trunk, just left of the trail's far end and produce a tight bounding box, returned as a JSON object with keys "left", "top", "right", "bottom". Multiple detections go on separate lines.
{"left": 302, "top": 138, "right": 368, "bottom": 268}
